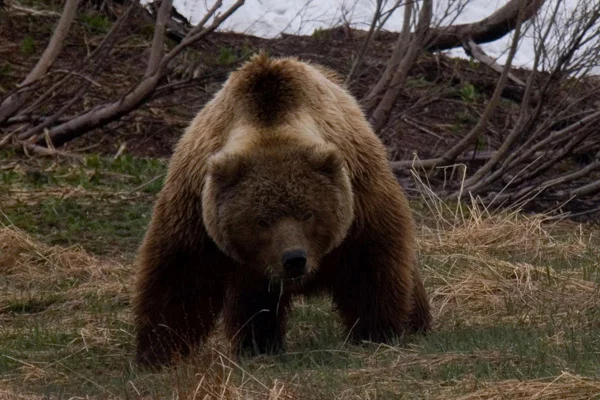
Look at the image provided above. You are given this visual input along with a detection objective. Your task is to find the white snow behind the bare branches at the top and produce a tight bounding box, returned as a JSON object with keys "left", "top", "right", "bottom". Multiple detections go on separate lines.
{"left": 174, "top": 0, "right": 600, "bottom": 73}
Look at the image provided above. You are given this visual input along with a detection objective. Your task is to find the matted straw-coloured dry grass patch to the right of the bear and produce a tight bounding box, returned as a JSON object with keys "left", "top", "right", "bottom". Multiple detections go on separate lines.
{"left": 418, "top": 173, "right": 598, "bottom": 324}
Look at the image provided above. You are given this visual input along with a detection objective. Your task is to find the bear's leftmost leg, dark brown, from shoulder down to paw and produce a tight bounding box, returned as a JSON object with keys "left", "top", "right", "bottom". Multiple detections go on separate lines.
{"left": 134, "top": 193, "right": 231, "bottom": 367}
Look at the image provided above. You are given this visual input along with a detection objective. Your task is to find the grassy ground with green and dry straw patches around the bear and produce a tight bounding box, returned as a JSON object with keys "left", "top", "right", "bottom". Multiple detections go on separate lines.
{"left": 0, "top": 153, "right": 600, "bottom": 399}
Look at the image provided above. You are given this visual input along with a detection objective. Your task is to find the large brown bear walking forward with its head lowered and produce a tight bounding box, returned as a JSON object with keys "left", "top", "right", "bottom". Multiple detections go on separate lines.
{"left": 135, "top": 55, "right": 431, "bottom": 366}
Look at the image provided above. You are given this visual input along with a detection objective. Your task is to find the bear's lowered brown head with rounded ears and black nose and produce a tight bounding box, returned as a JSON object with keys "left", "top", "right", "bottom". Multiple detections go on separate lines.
{"left": 202, "top": 145, "right": 354, "bottom": 282}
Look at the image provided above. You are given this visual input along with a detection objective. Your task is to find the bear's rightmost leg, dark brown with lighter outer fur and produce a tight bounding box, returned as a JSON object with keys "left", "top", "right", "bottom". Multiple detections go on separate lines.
{"left": 330, "top": 192, "right": 431, "bottom": 342}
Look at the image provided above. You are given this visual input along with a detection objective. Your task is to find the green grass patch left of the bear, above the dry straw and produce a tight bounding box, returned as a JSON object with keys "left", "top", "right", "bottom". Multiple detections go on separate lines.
{"left": 0, "top": 153, "right": 166, "bottom": 255}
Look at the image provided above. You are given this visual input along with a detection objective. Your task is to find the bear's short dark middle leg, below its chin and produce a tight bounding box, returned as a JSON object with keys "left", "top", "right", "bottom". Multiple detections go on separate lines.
{"left": 223, "top": 274, "right": 291, "bottom": 355}
